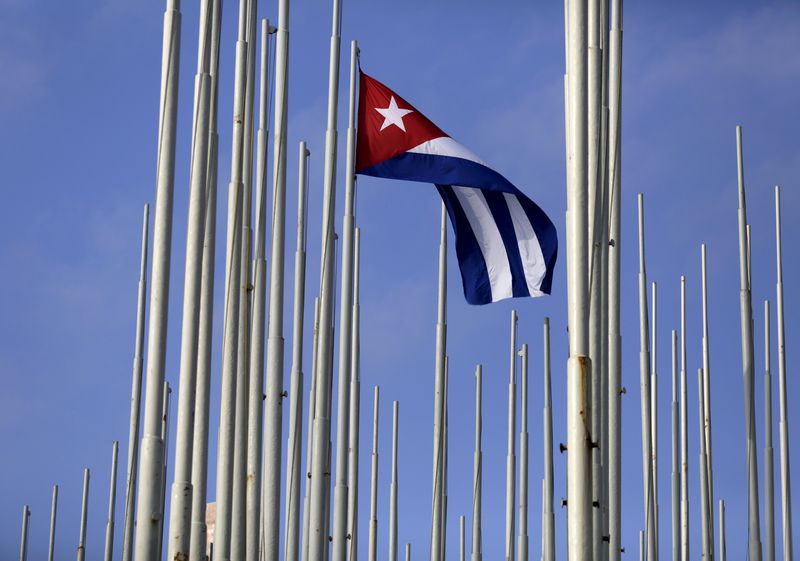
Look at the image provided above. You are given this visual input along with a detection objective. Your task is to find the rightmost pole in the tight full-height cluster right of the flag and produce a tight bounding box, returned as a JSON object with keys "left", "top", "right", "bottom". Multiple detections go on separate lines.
{"left": 608, "top": 0, "right": 622, "bottom": 561}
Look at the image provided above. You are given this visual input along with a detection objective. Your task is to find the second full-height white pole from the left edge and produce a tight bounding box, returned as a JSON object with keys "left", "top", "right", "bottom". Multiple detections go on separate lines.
{"left": 165, "top": 0, "right": 211, "bottom": 561}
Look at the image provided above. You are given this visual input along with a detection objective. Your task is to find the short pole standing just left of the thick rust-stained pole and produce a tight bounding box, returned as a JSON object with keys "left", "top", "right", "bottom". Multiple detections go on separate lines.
{"left": 542, "top": 317, "right": 556, "bottom": 561}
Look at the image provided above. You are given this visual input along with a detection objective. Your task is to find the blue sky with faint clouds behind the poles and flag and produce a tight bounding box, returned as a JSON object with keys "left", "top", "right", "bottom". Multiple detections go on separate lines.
{"left": 0, "top": 0, "right": 800, "bottom": 558}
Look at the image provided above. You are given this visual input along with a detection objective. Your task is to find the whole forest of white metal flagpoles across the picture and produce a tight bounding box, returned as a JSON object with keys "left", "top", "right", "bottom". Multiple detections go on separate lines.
{"left": 10, "top": 0, "right": 792, "bottom": 561}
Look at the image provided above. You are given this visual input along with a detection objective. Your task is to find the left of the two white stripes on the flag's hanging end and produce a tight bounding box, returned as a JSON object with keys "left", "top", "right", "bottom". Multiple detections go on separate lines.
{"left": 453, "top": 185, "right": 514, "bottom": 302}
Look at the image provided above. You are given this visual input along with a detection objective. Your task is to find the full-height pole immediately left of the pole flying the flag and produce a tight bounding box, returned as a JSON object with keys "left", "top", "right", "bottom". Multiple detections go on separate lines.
{"left": 304, "top": 0, "right": 342, "bottom": 561}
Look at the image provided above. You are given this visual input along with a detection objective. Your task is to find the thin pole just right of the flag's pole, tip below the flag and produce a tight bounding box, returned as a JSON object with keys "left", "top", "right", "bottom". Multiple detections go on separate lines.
{"left": 347, "top": 228, "right": 361, "bottom": 561}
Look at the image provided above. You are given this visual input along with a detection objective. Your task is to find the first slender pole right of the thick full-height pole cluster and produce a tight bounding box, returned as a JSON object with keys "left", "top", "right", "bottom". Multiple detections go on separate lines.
{"left": 638, "top": 193, "right": 656, "bottom": 560}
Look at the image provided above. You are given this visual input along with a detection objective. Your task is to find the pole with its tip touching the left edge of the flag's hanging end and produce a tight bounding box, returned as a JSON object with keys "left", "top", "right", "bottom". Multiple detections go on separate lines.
{"left": 431, "top": 203, "right": 447, "bottom": 561}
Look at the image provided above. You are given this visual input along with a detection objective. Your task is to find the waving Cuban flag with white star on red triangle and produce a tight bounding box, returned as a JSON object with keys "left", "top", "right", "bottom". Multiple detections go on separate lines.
{"left": 356, "top": 72, "right": 558, "bottom": 304}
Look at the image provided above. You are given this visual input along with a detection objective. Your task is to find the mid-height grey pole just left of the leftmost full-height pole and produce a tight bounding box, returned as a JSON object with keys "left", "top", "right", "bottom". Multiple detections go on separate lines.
{"left": 121, "top": 203, "right": 150, "bottom": 561}
